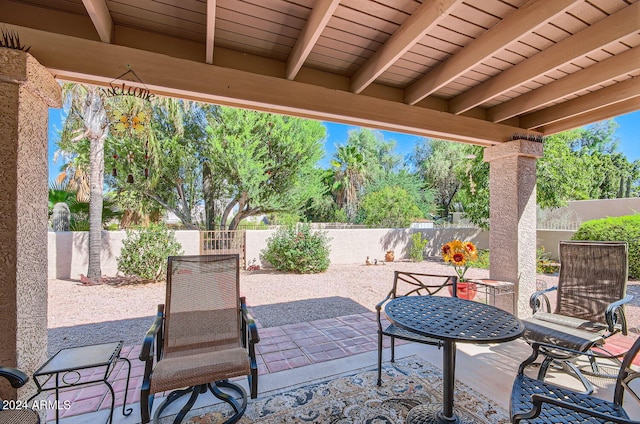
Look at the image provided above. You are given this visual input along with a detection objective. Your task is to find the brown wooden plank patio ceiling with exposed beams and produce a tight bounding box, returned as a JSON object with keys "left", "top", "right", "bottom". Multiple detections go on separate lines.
{"left": 0, "top": 0, "right": 640, "bottom": 145}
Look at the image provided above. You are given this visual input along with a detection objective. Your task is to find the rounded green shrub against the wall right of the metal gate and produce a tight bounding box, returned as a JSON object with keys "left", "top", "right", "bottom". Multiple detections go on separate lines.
{"left": 260, "top": 224, "right": 330, "bottom": 274}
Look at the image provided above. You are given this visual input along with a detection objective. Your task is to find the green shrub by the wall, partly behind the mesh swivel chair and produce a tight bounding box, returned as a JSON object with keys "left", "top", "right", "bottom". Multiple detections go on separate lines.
{"left": 116, "top": 224, "right": 182, "bottom": 281}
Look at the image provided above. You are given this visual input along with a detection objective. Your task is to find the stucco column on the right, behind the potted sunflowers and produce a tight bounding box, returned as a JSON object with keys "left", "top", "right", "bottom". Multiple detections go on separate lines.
{"left": 484, "top": 140, "right": 542, "bottom": 317}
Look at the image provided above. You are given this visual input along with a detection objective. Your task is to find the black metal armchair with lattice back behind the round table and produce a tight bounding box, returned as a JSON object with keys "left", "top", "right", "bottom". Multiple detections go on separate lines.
{"left": 376, "top": 271, "right": 458, "bottom": 386}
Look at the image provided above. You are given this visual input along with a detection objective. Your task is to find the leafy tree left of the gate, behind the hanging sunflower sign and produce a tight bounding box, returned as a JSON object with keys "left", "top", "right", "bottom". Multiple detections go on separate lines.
{"left": 110, "top": 98, "right": 207, "bottom": 229}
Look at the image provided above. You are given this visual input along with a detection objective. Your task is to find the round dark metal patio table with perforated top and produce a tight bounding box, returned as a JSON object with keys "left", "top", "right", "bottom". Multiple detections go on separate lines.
{"left": 385, "top": 296, "right": 524, "bottom": 424}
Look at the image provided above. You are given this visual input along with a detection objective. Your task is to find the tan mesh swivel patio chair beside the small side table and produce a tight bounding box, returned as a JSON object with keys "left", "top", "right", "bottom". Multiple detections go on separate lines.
{"left": 140, "top": 255, "right": 259, "bottom": 423}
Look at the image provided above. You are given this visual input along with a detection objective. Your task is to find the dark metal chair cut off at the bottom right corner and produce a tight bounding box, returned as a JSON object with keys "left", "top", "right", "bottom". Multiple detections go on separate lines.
{"left": 509, "top": 339, "right": 640, "bottom": 424}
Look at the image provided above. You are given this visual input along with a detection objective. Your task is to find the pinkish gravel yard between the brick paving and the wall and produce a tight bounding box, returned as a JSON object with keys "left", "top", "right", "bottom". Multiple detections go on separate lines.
{"left": 48, "top": 260, "right": 640, "bottom": 354}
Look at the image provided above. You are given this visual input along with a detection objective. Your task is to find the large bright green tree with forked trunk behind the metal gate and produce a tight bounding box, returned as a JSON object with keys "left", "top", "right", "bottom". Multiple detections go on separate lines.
{"left": 205, "top": 107, "right": 325, "bottom": 230}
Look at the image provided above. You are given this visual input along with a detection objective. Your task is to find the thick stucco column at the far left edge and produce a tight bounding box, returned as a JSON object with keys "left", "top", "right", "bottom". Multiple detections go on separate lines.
{"left": 0, "top": 48, "right": 61, "bottom": 399}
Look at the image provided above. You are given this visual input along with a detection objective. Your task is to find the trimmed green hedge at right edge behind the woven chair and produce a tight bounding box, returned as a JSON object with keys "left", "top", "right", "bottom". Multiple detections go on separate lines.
{"left": 572, "top": 214, "right": 640, "bottom": 279}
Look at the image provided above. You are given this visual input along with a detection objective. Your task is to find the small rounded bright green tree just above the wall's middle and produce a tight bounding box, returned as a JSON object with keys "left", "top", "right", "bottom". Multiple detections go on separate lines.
{"left": 360, "top": 186, "right": 422, "bottom": 228}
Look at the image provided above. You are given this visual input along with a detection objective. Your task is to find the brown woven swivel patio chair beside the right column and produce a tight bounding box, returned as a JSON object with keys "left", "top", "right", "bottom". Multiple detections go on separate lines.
{"left": 522, "top": 241, "right": 632, "bottom": 393}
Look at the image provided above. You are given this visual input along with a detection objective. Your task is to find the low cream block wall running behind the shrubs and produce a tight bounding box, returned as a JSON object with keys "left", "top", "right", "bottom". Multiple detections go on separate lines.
{"left": 48, "top": 228, "right": 574, "bottom": 279}
